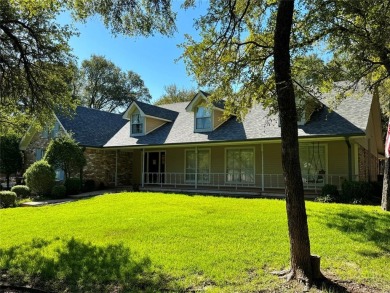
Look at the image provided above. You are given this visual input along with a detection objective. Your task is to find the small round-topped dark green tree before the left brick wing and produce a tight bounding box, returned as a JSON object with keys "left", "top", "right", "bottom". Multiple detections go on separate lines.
{"left": 43, "top": 134, "right": 86, "bottom": 180}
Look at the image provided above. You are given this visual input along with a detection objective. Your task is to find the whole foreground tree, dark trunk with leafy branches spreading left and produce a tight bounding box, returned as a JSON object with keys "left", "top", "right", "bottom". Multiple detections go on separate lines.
{"left": 183, "top": 0, "right": 319, "bottom": 286}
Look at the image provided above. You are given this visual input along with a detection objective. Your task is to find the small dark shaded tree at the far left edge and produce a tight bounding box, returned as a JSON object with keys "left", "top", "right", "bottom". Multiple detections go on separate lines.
{"left": 0, "top": 135, "right": 23, "bottom": 188}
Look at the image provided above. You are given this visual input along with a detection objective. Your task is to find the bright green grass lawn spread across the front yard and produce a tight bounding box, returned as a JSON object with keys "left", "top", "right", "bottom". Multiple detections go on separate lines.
{"left": 0, "top": 193, "right": 390, "bottom": 292}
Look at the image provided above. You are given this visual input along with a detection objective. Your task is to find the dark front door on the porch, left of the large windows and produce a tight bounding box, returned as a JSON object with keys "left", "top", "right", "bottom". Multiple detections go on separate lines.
{"left": 144, "top": 152, "right": 165, "bottom": 183}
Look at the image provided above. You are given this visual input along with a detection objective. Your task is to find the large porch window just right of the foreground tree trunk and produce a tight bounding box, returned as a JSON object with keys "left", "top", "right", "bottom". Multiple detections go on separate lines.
{"left": 299, "top": 143, "right": 326, "bottom": 183}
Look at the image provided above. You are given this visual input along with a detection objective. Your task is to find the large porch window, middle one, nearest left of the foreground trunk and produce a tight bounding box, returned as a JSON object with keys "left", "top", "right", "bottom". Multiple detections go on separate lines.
{"left": 226, "top": 148, "right": 255, "bottom": 183}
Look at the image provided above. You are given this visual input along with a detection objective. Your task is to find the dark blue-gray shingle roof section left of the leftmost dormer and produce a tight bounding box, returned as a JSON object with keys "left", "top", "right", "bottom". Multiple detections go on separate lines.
{"left": 56, "top": 106, "right": 127, "bottom": 147}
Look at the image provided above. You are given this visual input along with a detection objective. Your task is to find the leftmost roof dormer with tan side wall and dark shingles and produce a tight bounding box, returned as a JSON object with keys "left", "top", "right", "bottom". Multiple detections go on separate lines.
{"left": 123, "top": 101, "right": 177, "bottom": 137}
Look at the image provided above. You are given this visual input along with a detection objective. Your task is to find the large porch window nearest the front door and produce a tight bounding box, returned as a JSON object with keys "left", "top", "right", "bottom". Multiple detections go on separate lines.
{"left": 185, "top": 149, "right": 210, "bottom": 183}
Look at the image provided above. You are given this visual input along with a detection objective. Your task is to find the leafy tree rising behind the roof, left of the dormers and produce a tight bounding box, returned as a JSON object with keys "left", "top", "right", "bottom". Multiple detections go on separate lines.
{"left": 79, "top": 55, "right": 151, "bottom": 112}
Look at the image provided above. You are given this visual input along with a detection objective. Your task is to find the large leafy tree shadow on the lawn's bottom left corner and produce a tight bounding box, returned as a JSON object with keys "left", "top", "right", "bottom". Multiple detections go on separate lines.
{"left": 0, "top": 238, "right": 173, "bottom": 292}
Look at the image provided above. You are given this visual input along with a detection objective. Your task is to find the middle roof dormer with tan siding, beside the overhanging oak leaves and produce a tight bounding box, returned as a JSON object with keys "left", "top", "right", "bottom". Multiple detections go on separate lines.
{"left": 186, "top": 91, "right": 226, "bottom": 132}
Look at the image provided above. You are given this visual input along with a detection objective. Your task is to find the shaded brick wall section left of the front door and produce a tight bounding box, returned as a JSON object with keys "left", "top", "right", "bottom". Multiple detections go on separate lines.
{"left": 83, "top": 148, "right": 133, "bottom": 186}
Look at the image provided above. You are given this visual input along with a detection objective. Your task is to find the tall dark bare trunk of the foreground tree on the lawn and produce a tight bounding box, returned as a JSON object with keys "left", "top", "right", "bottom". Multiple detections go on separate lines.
{"left": 274, "top": 0, "right": 312, "bottom": 286}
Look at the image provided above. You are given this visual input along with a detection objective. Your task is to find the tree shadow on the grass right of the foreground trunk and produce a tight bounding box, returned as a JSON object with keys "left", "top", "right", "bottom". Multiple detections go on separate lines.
{"left": 317, "top": 208, "right": 390, "bottom": 253}
